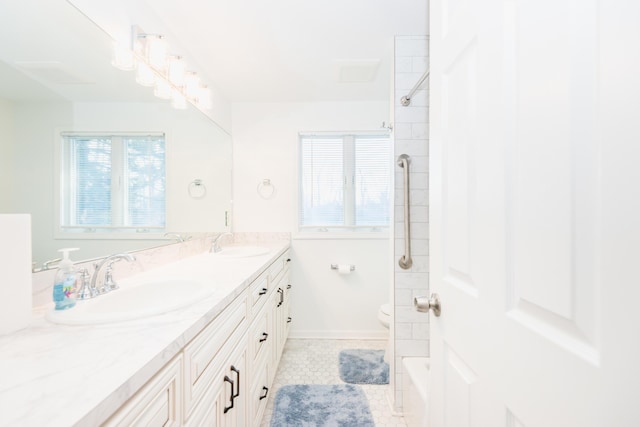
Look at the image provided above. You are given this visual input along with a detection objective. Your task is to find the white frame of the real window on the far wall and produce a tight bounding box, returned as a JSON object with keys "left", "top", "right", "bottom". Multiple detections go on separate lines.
{"left": 292, "top": 131, "right": 394, "bottom": 240}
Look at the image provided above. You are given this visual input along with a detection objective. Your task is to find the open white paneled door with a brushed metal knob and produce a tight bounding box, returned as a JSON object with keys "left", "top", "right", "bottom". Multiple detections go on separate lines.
{"left": 430, "top": 0, "right": 640, "bottom": 427}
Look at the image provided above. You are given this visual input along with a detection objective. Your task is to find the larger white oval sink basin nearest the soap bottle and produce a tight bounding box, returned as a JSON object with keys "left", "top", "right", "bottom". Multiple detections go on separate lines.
{"left": 46, "top": 279, "right": 213, "bottom": 325}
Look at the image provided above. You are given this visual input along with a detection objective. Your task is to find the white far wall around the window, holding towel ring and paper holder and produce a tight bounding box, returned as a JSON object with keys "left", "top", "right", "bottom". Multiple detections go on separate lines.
{"left": 232, "top": 102, "right": 392, "bottom": 338}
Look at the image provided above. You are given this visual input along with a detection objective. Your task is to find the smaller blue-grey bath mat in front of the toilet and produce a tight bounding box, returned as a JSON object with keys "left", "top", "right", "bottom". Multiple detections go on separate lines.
{"left": 339, "top": 349, "right": 389, "bottom": 384}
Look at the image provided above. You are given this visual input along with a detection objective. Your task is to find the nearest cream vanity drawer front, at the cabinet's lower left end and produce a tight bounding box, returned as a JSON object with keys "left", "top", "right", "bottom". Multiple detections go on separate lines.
{"left": 103, "top": 355, "right": 182, "bottom": 427}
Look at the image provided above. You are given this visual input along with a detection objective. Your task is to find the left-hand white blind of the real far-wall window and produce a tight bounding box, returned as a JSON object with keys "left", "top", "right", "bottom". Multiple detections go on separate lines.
{"left": 299, "top": 136, "right": 344, "bottom": 227}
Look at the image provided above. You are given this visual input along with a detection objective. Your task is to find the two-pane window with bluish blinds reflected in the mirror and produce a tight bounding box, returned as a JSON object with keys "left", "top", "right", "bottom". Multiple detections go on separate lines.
{"left": 60, "top": 134, "right": 166, "bottom": 233}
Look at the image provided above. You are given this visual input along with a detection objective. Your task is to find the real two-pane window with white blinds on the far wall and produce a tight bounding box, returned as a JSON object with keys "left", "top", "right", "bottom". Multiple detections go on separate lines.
{"left": 298, "top": 134, "right": 392, "bottom": 231}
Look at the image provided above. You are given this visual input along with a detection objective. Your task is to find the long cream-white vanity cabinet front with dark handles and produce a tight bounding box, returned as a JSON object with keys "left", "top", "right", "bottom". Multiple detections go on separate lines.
{"left": 105, "top": 247, "right": 291, "bottom": 427}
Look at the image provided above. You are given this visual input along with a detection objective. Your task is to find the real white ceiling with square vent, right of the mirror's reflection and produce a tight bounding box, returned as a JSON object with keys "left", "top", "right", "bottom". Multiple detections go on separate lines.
{"left": 147, "top": 0, "right": 428, "bottom": 102}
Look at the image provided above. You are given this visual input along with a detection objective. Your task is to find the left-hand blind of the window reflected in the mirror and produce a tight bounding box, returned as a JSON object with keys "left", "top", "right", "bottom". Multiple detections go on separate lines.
{"left": 67, "top": 137, "right": 111, "bottom": 226}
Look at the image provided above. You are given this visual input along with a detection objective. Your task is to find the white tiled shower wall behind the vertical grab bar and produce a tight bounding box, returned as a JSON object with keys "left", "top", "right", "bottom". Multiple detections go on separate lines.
{"left": 390, "top": 36, "right": 429, "bottom": 411}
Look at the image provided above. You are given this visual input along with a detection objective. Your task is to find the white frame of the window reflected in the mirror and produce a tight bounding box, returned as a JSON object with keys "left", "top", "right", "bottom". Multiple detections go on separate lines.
{"left": 52, "top": 129, "right": 169, "bottom": 240}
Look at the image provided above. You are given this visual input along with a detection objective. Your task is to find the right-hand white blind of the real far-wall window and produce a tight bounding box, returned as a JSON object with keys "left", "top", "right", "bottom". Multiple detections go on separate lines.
{"left": 354, "top": 135, "right": 392, "bottom": 227}
